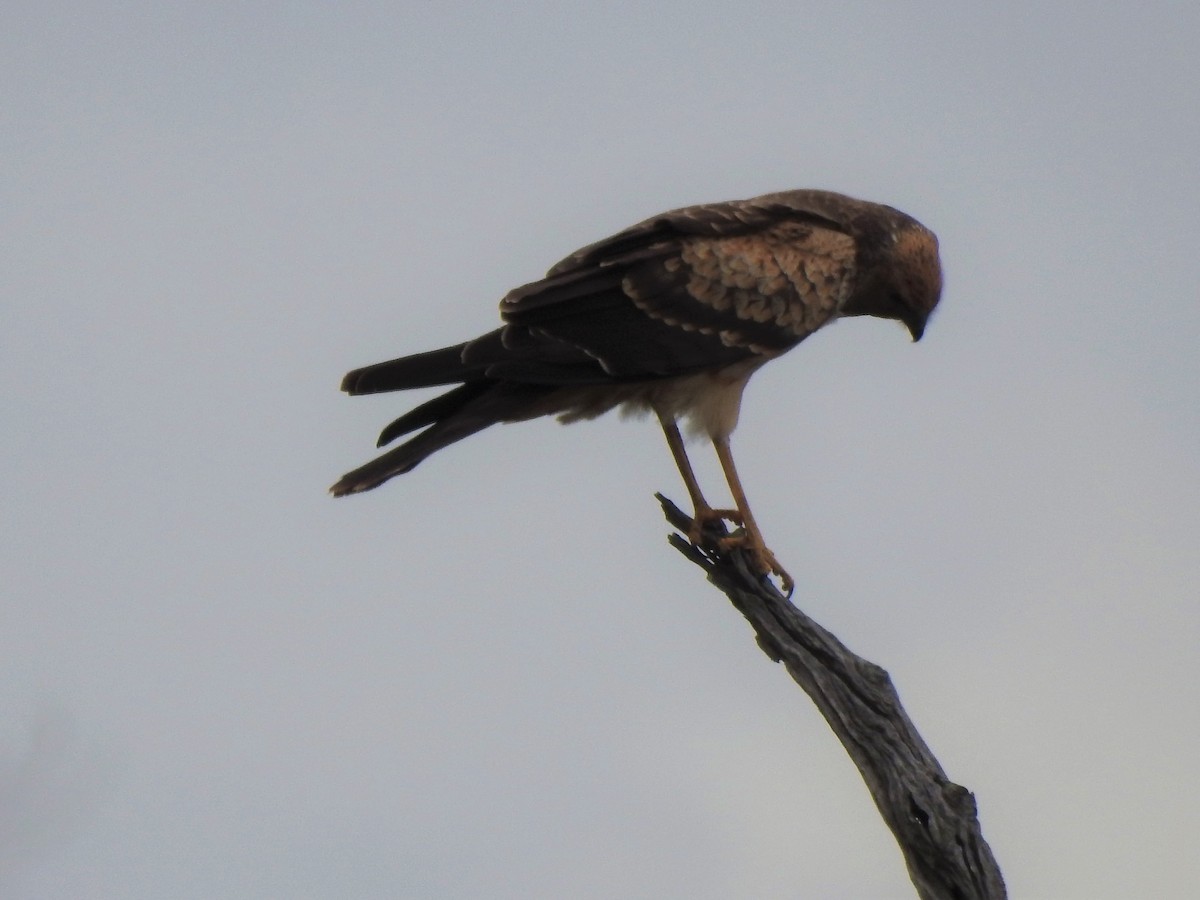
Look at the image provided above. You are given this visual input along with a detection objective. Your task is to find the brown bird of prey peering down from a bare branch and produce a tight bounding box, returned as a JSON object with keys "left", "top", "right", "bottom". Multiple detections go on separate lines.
{"left": 330, "top": 191, "right": 942, "bottom": 592}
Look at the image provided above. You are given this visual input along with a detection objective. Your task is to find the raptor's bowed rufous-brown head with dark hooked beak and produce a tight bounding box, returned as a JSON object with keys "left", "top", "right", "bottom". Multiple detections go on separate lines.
{"left": 842, "top": 220, "right": 942, "bottom": 341}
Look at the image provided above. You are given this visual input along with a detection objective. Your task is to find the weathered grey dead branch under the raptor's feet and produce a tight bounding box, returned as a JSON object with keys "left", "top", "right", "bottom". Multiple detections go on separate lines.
{"left": 658, "top": 494, "right": 1007, "bottom": 900}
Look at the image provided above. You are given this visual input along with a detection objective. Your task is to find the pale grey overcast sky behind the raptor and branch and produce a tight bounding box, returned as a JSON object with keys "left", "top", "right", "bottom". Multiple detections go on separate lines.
{"left": 0, "top": 0, "right": 1200, "bottom": 900}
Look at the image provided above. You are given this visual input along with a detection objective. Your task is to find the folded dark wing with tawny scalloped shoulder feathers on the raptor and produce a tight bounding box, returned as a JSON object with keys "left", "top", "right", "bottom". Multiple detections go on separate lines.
{"left": 463, "top": 202, "right": 856, "bottom": 384}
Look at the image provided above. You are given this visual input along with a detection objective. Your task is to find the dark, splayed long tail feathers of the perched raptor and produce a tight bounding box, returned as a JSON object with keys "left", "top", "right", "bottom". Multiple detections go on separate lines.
{"left": 329, "top": 336, "right": 554, "bottom": 497}
